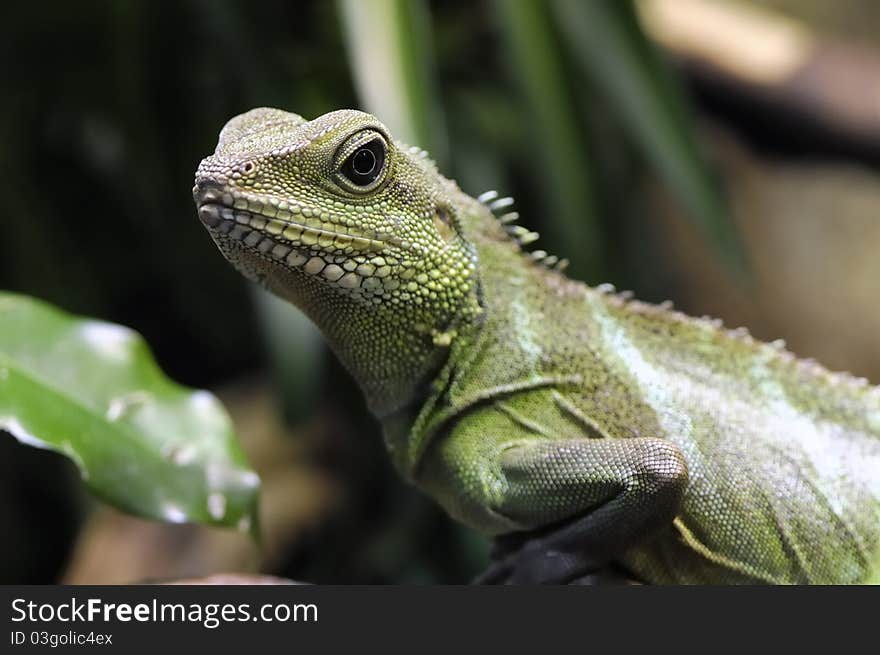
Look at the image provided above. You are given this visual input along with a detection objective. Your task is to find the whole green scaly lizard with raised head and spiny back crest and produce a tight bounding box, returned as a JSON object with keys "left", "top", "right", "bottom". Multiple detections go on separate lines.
{"left": 193, "top": 109, "right": 880, "bottom": 583}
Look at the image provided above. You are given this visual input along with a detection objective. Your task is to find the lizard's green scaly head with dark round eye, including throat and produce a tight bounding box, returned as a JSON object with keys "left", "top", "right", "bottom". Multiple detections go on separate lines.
{"left": 193, "top": 108, "right": 476, "bottom": 412}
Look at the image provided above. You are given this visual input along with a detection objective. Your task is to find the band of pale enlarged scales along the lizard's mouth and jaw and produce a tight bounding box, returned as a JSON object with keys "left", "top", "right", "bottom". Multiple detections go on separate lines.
{"left": 199, "top": 197, "right": 399, "bottom": 295}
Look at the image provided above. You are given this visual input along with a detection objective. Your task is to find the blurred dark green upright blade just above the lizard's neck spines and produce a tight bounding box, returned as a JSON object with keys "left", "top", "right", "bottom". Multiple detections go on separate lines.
{"left": 493, "top": 0, "right": 605, "bottom": 282}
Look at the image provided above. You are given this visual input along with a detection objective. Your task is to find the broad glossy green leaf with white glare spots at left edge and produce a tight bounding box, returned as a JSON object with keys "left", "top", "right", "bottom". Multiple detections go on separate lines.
{"left": 0, "top": 292, "right": 259, "bottom": 530}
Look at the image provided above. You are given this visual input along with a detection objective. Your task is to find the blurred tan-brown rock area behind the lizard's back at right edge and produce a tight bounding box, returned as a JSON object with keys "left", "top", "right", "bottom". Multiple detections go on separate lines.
{"left": 652, "top": 125, "right": 880, "bottom": 383}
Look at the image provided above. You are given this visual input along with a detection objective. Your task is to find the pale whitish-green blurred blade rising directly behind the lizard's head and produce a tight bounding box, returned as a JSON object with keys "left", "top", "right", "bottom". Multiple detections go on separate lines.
{"left": 338, "top": 0, "right": 447, "bottom": 166}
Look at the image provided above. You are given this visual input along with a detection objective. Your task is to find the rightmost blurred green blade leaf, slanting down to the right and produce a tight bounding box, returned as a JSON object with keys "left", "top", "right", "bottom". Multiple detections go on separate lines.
{"left": 553, "top": 0, "right": 747, "bottom": 275}
